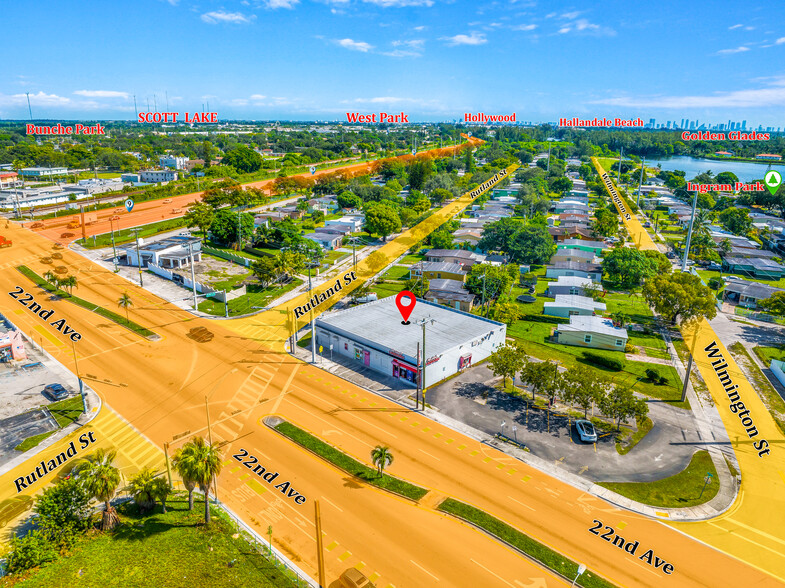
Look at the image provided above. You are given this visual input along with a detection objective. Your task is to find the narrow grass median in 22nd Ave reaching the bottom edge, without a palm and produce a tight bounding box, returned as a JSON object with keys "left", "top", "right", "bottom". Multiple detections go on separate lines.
{"left": 439, "top": 498, "right": 615, "bottom": 588}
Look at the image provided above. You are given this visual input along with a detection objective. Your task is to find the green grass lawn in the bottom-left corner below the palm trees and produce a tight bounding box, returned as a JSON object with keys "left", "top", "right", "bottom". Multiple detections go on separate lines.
{"left": 0, "top": 495, "right": 304, "bottom": 588}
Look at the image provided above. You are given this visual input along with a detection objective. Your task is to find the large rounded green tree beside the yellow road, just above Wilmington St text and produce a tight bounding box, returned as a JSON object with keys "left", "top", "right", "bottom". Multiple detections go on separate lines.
{"left": 642, "top": 272, "right": 717, "bottom": 324}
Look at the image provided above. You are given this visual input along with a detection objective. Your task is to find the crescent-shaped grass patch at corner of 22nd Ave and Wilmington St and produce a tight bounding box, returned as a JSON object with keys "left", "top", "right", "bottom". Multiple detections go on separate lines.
{"left": 598, "top": 451, "right": 719, "bottom": 508}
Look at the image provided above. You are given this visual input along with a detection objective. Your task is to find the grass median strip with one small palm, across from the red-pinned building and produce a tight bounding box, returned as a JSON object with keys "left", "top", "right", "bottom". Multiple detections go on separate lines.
{"left": 275, "top": 421, "right": 428, "bottom": 500}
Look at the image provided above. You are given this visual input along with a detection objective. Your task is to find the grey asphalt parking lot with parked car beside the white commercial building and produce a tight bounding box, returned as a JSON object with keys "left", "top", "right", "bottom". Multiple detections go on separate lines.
{"left": 427, "top": 364, "right": 719, "bottom": 482}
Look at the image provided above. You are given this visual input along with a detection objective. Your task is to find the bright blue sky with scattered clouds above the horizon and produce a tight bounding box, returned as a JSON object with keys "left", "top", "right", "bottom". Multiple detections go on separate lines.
{"left": 6, "top": 0, "right": 785, "bottom": 126}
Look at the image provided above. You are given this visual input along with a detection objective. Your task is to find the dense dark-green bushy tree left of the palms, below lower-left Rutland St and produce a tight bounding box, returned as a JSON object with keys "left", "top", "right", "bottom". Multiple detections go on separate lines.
{"left": 34, "top": 477, "right": 92, "bottom": 550}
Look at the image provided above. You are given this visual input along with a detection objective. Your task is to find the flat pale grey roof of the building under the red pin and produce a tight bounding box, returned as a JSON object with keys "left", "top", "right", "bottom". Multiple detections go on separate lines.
{"left": 316, "top": 296, "right": 504, "bottom": 357}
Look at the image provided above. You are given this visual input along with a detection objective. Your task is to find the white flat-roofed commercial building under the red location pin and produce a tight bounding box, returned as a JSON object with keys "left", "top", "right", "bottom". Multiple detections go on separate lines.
{"left": 316, "top": 296, "right": 507, "bottom": 387}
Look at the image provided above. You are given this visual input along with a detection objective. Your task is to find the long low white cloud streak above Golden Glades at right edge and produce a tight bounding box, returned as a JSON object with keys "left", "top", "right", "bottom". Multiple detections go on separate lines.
{"left": 592, "top": 78, "right": 785, "bottom": 108}
